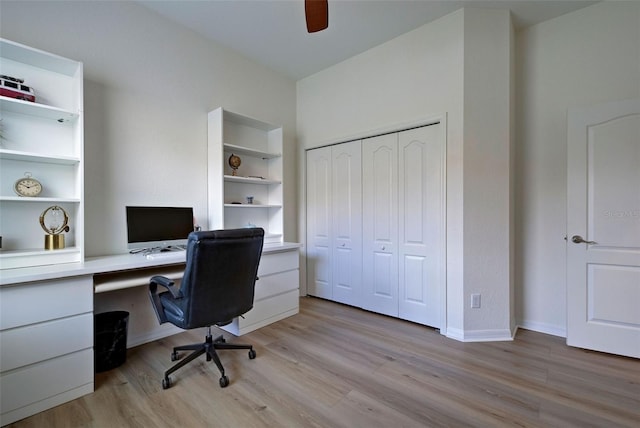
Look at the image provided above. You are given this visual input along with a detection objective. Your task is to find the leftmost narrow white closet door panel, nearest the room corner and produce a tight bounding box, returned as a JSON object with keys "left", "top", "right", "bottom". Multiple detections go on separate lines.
{"left": 307, "top": 147, "right": 332, "bottom": 299}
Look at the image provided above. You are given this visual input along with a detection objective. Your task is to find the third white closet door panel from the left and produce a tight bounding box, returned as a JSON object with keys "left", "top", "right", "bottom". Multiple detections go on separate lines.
{"left": 362, "top": 134, "right": 398, "bottom": 316}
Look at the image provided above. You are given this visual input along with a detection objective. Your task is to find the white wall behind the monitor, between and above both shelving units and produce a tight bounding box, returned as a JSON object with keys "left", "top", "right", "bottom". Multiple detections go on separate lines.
{"left": 0, "top": 1, "right": 297, "bottom": 256}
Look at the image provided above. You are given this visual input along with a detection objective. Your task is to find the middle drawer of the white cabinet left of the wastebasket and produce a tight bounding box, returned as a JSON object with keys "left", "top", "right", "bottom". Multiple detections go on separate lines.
{"left": 0, "top": 313, "right": 93, "bottom": 372}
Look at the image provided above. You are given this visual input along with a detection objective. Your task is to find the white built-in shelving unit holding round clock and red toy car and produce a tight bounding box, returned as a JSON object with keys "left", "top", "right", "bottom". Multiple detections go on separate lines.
{"left": 0, "top": 39, "right": 84, "bottom": 269}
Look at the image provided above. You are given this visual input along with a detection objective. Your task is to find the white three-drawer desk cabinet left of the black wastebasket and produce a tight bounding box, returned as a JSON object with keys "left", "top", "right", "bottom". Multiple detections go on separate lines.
{"left": 0, "top": 275, "right": 94, "bottom": 426}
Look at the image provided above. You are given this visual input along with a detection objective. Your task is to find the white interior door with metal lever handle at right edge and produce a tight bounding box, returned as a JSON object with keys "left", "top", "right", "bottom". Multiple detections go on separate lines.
{"left": 567, "top": 100, "right": 640, "bottom": 358}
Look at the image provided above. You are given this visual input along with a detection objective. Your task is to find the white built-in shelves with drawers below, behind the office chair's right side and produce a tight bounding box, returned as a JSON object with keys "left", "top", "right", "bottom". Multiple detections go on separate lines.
{"left": 208, "top": 108, "right": 300, "bottom": 335}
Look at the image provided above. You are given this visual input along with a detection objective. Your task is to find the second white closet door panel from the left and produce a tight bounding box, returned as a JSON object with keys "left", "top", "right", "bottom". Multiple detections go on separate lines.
{"left": 331, "top": 140, "right": 362, "bottom": 306}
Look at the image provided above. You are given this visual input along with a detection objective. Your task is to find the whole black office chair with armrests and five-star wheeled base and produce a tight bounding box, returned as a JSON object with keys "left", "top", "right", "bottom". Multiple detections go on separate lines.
{"left": 149, "top": 228, "right": 264, "bottom": 389}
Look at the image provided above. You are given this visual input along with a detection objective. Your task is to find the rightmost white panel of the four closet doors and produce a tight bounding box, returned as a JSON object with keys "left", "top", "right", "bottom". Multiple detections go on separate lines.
{"left": 397, "top": 125, "right": 444, "bottom": 327}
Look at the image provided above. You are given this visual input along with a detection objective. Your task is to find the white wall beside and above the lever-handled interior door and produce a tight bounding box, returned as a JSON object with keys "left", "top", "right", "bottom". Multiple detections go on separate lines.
{"left": 516, "top": 2, "right": 640, "bottom": 336}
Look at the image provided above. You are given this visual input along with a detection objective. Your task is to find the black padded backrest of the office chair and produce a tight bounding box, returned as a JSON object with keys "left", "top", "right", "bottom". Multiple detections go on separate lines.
{"left": 180, "top": 228, "right": 264, "bottom": 328}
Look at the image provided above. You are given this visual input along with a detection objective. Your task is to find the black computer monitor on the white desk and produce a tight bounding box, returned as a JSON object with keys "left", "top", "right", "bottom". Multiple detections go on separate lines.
{"left": 126, "top": 206, "right": 194, "bottom": 250}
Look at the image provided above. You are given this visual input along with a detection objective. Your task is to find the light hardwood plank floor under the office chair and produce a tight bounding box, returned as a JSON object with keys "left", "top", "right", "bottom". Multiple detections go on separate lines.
{"left": 12, "top": 298, "right": 640, "bottom": 428}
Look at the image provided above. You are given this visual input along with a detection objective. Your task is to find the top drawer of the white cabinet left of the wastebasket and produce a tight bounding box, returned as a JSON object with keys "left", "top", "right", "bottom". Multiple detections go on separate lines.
{"left": 0, "top": 276, "right": 93, "bottom": 330}
